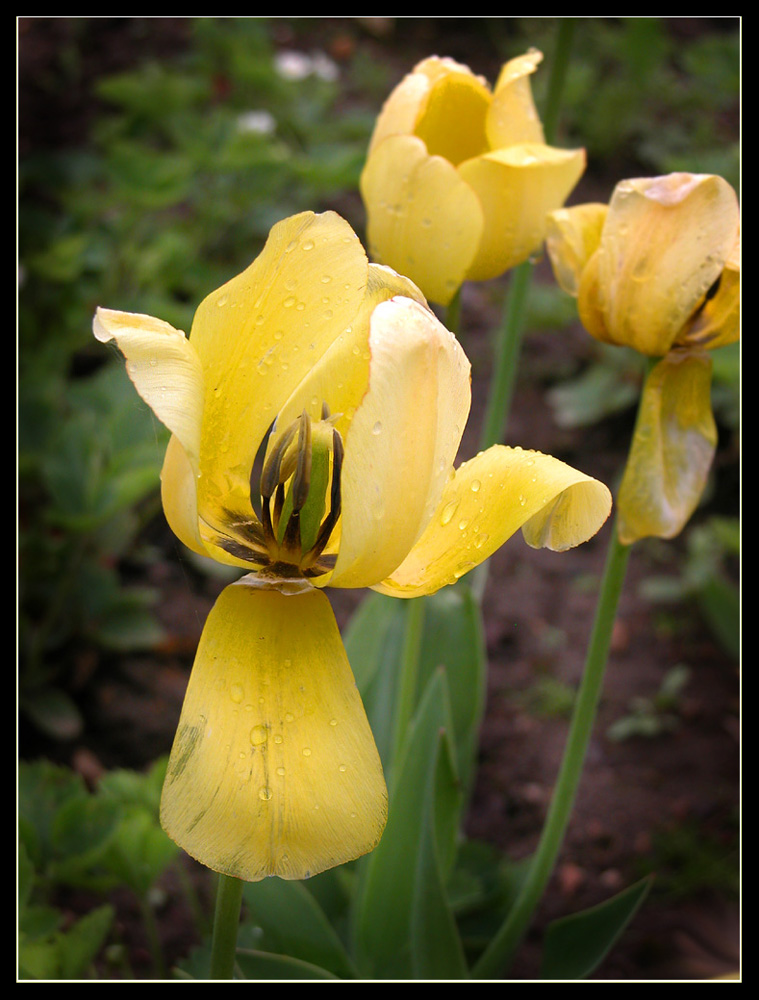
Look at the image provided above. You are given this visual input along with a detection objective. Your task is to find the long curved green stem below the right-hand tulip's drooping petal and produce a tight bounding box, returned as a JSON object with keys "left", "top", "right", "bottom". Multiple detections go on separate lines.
{"left": 472, "top": 524, "right": 630, "bottom": 979}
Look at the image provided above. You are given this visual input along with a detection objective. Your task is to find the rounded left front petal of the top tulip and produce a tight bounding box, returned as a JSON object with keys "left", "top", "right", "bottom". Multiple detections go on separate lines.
{"left": 361, "top": 136, "right": 484, "bottom": 305}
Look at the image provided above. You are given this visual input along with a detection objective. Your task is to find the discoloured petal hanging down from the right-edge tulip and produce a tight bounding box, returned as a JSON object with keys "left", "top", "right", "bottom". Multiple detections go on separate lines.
{"left": 617, "top": 350, "right": 717, "bottom": 545}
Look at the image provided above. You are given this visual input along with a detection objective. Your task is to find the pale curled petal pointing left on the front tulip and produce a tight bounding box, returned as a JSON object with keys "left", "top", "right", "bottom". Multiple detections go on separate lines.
{"left": 92, "top": 308, "right": 205, "bottom": 473}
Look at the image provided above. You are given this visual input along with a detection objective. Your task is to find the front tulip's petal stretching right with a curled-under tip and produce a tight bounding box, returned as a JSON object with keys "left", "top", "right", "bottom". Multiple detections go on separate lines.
{"left": 374, "top": 445, "right": 611, "bottom": 597}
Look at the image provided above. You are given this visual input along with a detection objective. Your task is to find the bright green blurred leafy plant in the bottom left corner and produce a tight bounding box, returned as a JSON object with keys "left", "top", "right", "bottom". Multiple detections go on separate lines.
{"left": 18, "top": 760, "right": 179, "bottom": 980}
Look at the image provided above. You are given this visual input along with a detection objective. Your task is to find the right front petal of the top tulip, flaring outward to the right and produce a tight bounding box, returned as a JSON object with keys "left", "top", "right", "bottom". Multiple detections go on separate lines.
{"left": 458, "top": 143, "right": 585, "bottom": 281}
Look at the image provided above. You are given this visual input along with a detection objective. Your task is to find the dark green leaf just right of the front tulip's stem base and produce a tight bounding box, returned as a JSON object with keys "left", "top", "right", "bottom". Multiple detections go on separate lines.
{"left": 243, "top": 878, "right": 356, "bottom": 979}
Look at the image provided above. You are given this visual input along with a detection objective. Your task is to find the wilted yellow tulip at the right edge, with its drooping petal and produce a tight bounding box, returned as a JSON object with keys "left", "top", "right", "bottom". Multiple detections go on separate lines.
{"left": 547, "top": 173, "right": 740, "bottom": 544}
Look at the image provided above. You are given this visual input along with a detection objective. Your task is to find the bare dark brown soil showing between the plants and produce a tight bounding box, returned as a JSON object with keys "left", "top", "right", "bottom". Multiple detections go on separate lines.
{"left": 20, "top": 19, "right": 739, "bottom": 981}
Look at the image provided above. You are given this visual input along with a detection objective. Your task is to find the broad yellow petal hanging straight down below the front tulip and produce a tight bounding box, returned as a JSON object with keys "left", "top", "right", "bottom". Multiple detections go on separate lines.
{"left": 161, "top": 578, "right": 387, "bottom": 882}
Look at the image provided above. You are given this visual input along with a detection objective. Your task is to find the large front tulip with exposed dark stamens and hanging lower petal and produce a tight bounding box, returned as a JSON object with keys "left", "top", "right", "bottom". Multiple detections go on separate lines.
{"left": 94, "top": 212, "right": 611, "bottom": 881}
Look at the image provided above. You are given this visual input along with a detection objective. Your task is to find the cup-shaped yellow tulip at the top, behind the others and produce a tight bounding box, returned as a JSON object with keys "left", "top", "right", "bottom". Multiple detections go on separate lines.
{"left": 361, "top": 50, "right": 585, "bottom": 305}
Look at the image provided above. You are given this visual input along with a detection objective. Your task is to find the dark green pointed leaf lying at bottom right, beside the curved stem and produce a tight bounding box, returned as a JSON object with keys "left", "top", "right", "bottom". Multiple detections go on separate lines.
{"left": 540, "top": 878, "right": 652, "bottom": 979}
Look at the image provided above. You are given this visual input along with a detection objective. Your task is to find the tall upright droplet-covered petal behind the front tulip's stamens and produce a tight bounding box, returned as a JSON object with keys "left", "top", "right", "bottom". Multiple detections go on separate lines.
{"left": 190, "top": 212, "right": 368, "bottom": 524}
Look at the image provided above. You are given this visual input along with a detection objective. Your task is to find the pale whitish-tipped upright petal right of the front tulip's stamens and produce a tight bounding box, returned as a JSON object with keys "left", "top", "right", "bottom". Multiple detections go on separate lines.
{"left": 329, "top": 297, "right": 471, "bottom": 587}
